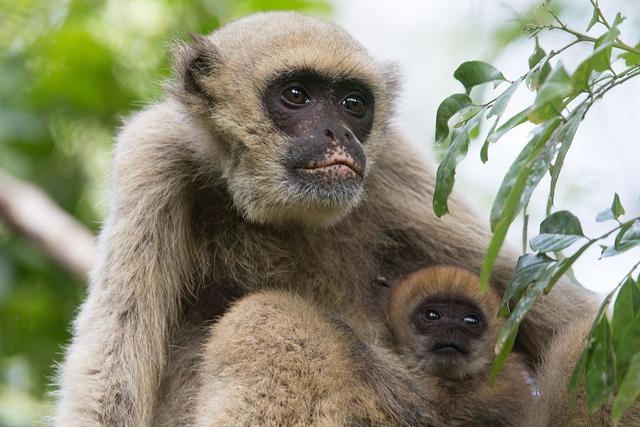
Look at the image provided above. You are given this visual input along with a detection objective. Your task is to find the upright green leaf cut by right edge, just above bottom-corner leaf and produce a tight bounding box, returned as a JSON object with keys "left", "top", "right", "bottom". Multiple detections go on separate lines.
{"left": 611, "top": 277, "right": 640, "bottom": 381}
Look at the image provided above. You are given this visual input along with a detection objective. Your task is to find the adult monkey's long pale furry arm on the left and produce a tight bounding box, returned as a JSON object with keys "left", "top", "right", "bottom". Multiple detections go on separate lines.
{"left": 55, "top": 104, "right": 200, "bottom": 427}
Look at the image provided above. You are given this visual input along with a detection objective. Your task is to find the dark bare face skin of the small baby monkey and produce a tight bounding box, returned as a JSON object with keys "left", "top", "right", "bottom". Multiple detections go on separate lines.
{"left": 410, "top": 297, "right": 487, "bottom": 376}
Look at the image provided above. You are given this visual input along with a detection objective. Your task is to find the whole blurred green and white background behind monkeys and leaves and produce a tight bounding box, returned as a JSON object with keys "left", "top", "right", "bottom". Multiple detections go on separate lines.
{"left": 0, "top": 0, "right": 640, "bottom": 426}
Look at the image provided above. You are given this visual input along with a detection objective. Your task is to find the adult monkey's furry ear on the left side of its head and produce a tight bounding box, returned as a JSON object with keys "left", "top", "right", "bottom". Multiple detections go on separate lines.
{"left": 173, "top": 33, "right": 221, "bottom": 97}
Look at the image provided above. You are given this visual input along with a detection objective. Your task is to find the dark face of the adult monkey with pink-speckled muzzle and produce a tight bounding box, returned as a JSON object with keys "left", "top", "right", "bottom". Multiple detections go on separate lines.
{"left": 264, "top": 71, "right": 374, "bottom": 201}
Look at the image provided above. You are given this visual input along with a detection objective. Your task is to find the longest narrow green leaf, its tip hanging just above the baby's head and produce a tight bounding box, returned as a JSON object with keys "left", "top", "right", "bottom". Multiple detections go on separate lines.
{"left": 480, "top": 119, "right": 560, "bottom": 290}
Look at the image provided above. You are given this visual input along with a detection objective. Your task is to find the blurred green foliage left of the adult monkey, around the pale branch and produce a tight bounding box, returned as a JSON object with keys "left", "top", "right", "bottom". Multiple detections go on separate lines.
{"left": 0, "top": 0, "right": 331, "bottom": 426}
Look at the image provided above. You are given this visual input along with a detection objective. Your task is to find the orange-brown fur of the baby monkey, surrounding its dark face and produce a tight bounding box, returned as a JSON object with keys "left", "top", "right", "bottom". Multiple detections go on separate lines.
{"left": 388, "top": 266, "right": 533, "bottom": 426}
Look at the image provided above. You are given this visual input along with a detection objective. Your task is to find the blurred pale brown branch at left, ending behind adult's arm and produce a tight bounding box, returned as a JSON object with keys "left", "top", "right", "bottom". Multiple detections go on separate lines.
{"left": 0, "top": 170, "right": 96, "bottom": 278}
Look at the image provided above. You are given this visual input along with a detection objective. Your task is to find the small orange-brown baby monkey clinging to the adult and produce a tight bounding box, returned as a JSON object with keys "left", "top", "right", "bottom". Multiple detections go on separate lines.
{"left": 387, "top": 266, "right": 534, "bottom": 426}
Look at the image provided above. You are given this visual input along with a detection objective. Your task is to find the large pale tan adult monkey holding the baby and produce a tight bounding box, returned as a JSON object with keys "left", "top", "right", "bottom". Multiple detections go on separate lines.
{"left": 56, "top": 13, "right": 593, "bottom": 426}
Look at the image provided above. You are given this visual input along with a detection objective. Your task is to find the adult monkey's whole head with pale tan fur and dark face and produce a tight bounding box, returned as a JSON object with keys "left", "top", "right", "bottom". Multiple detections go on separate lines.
{"left": 172, "top": 12, "right": 395, "bottom": 226}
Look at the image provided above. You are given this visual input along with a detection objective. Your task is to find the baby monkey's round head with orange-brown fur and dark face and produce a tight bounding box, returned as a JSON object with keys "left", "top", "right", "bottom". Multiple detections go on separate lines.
{"left": 388, "top": 266, "right": 499, "bottom": 379}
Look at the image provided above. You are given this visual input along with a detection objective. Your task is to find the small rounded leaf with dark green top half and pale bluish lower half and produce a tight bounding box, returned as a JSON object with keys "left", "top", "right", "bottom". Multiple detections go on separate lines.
{"left": 529, "top": 211, "right": 584, "bottom": 252}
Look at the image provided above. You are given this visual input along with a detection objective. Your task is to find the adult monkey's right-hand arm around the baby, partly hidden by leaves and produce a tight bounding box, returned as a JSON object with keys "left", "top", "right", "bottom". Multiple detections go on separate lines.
{"left": 369, "top": 136, "right": 597, "bottom": 359}
